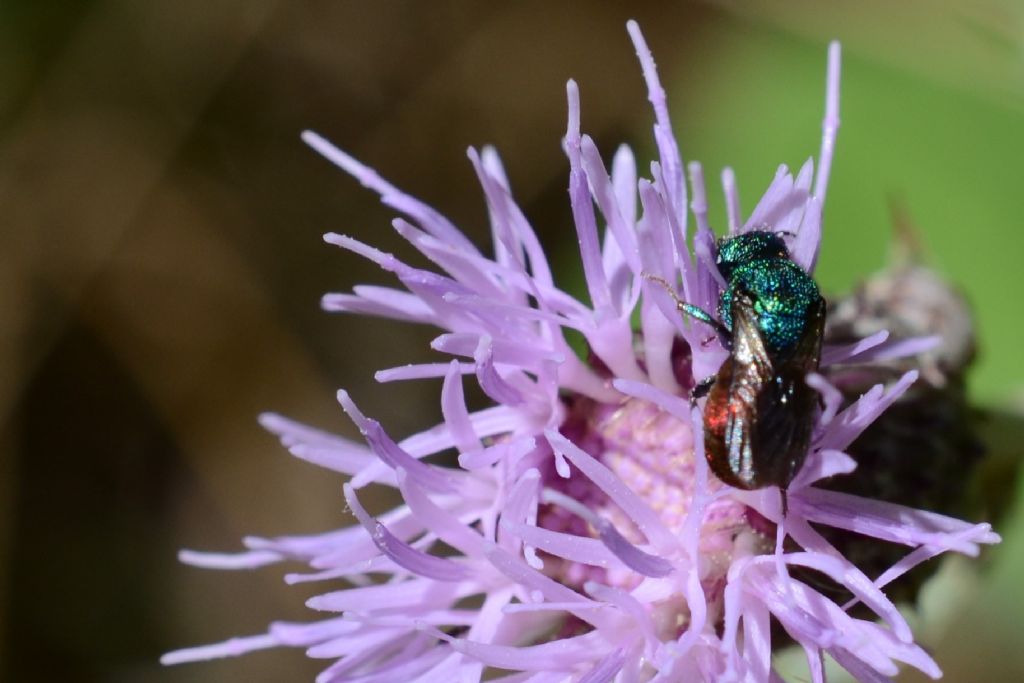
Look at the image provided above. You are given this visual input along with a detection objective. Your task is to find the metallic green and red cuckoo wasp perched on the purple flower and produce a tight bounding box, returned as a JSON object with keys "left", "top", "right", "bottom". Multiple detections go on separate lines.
{"left": 655, "top": 230, "right": 825, "bottom": 514}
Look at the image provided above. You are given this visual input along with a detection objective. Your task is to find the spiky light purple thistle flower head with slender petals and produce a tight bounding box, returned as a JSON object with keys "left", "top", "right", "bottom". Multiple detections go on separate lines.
{"left": 164, "top": 22, "right": 998, "bottom": 683}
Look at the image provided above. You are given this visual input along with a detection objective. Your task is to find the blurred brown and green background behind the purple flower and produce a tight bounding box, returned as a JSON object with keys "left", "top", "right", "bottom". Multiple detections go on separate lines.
{"left": 0, "top": 0, "right": 1024, "bottom": 683}
